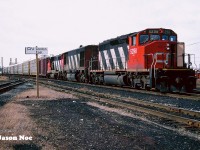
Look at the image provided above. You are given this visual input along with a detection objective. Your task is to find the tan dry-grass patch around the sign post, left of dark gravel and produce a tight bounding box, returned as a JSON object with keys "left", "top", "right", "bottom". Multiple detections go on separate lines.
{"left": 0, "top": 86, "right": 77, "bottom": 150}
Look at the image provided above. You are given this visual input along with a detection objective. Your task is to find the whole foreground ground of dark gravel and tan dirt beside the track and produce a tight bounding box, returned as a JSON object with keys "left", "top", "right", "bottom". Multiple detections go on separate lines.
{"left": 0, "top": 87, "right": 200, "bottom": 150}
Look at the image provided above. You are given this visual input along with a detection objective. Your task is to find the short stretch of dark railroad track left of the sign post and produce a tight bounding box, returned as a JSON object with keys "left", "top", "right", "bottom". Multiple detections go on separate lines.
{"left": 0, "top": 80, "right": 25, "bottom": 94}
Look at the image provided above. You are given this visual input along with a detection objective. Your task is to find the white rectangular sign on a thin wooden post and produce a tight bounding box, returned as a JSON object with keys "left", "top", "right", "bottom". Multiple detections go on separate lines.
{"left": 25, "top": 46, "right": 48, "bottom": 98}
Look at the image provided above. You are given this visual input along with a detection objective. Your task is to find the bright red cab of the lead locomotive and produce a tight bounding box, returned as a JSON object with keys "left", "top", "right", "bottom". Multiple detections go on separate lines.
{"left": 128, "top": 29, "right": 178, "bottom": 70}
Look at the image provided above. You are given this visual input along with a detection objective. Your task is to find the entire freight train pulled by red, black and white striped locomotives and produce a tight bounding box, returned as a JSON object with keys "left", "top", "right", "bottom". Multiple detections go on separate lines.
{"left": 4, "top": 28, "right": 196, "bottom": 92}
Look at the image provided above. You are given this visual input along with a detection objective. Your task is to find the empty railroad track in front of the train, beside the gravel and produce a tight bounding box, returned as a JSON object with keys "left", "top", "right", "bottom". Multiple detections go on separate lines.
{"left": 30, "top": 78, "right": 200, "bottom": 130}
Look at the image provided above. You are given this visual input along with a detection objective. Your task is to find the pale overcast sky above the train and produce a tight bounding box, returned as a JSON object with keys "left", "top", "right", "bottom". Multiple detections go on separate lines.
{"left": 0, "top": 0, "right": 200, "bottom": 67}
